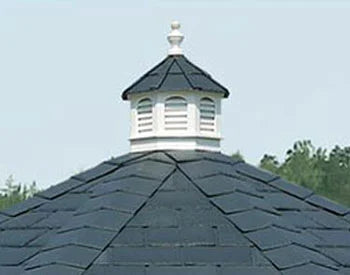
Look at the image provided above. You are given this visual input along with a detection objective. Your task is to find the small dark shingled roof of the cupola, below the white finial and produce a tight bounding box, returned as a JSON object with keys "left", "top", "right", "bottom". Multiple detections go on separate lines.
{"left": 122, "top": 55, "right": 229, "bottom": 100}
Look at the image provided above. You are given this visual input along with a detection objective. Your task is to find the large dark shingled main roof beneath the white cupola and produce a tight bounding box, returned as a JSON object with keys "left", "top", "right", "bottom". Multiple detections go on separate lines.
{"left": 0, "top": 151, "right": 350, "bottom": 275}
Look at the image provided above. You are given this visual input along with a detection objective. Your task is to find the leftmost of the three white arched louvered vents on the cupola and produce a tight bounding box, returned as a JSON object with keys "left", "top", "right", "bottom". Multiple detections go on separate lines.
{"left": 137, "top": 98, "right": 153, "bottom": 133}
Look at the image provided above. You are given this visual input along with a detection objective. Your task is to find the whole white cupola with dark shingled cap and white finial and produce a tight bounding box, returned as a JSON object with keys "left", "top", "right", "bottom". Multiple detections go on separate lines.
{"left": 122, "top": 21, "right": 229, "bottom": 152}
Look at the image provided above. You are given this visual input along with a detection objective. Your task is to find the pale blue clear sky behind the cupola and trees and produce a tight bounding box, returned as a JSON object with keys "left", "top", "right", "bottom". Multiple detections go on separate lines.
{"left": 0, "top": 0, "right": 350, "bottom": 188}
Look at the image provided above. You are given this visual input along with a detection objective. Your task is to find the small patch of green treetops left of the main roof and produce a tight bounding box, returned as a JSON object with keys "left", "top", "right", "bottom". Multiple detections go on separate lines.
{"left": 0, "top": 176, "right": 38, "bottom": 212}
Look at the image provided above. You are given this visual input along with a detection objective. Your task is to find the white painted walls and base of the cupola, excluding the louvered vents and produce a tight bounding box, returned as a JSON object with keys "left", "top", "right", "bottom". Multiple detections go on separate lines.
{"left": 129, "top": 91, "right": 222, "bottom": 152}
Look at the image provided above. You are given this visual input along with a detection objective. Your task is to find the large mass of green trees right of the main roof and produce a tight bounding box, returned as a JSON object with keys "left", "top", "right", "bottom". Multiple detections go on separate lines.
{"left": 260, "top": 140, "right": 350, "bottom": 206}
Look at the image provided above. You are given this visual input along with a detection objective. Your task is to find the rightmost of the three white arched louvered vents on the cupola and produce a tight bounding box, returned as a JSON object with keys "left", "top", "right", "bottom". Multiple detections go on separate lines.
{"left": 200, "top": 97, "right": 215, "bottom": 133}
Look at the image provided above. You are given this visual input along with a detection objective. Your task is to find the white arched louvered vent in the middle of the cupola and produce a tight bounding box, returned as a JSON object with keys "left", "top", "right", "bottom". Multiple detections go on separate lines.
{"left": 165, "top": 96, "right": 187, "bottom": 131}
